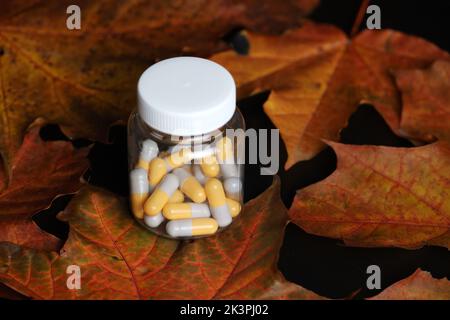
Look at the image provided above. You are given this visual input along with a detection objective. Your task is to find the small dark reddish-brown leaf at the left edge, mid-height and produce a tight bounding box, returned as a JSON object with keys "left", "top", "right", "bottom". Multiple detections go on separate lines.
{"left": 0, "top": 124, "right": 88, "bottom": 250}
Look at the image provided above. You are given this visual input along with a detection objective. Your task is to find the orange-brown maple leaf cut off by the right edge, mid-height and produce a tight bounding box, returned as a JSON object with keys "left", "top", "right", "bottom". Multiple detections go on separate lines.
{"left": 289, "top": 142, "right": 450, "bottom": 248}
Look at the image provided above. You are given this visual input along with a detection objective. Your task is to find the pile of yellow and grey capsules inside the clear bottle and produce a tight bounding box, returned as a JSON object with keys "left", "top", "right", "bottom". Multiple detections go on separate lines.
{"left": 130, "top": 137, "right": 242, "bottom": 238}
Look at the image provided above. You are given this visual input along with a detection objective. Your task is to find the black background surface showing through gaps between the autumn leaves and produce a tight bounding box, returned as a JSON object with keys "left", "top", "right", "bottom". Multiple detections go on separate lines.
{"left": 34, "top": 0, "right": 450, "bottom": 298}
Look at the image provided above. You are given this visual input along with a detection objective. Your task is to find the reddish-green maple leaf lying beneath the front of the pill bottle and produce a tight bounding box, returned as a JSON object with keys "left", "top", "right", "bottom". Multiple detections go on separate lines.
{"left": 0, "top": 178, "right": 320, "bottom": 299}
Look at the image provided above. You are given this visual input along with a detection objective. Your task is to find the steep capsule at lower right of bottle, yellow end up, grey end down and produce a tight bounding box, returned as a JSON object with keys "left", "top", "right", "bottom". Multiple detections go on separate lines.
{"left": 205, "top": 178, "right": 232, "bottom": 227}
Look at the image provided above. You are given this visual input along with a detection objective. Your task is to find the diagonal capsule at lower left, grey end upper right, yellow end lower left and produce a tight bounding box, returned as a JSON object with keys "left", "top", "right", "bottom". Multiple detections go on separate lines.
{"left": 144, "top": 173, "right": 179, "bottom": 216}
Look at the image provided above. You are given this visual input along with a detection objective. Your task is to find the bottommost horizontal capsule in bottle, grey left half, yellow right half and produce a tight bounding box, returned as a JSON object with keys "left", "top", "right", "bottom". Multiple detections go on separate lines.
{"left": 166, "top": 218, "right": 218, "bottom": 238}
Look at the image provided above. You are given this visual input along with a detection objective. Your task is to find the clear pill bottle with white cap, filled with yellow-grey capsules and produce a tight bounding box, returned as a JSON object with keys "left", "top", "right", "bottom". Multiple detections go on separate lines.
{"left": 128, "top": 57, "right": 245, "bottom": 239}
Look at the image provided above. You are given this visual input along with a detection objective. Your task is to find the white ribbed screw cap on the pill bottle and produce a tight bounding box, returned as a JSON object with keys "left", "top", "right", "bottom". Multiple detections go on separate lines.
{"left": 138, "top": 57, "right": 236, "bottom": 136}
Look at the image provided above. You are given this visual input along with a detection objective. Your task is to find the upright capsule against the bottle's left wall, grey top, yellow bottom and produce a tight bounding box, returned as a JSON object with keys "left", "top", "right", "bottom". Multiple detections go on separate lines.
{"left": 130, "top": 168, "right": 149, "bottom": 219}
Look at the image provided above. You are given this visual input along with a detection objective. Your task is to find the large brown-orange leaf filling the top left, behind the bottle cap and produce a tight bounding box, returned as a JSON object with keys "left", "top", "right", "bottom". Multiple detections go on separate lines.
{"left": 0, "top": 0, "right": 317, "bottom": 173}
